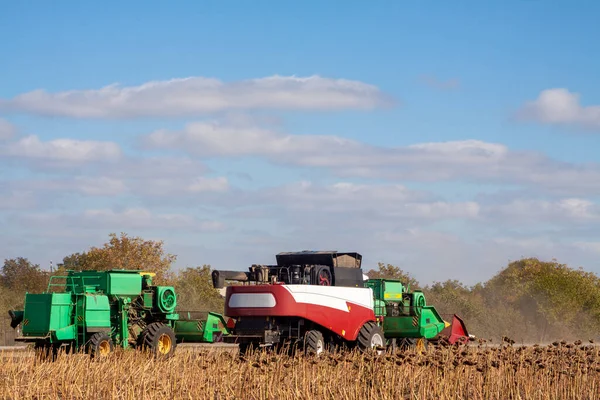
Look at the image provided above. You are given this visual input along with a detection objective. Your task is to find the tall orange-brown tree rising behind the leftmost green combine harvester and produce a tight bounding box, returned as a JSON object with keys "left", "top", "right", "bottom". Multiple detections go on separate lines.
{"left": 63, "top": 233, "right": 177, "bottom": 284}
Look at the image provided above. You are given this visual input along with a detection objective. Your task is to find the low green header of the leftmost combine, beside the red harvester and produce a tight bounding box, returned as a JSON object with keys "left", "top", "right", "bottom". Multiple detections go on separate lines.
{"left": 175, "top": 312, "right": 229, "bottom": 343}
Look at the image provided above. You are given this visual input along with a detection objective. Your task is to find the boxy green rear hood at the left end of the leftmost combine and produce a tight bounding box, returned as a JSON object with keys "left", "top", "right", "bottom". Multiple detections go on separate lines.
{"left": 23, "top": 293, "right": 73, "bottom": 337}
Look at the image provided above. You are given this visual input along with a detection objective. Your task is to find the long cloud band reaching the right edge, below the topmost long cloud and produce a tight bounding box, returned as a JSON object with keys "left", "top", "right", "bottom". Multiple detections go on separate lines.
{"left": 143, "top": 122, "right": 600, "bottom": 196}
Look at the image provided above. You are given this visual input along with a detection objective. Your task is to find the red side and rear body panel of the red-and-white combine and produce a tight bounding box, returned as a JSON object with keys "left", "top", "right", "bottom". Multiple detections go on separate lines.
{"left": 225, "top": 285, "right": 375, "bottom": 341}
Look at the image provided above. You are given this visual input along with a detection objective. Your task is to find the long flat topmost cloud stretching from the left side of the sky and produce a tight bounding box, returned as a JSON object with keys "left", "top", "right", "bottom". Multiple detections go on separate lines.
{"left": 0, "top": 75, "right": 392, "bottom": 118}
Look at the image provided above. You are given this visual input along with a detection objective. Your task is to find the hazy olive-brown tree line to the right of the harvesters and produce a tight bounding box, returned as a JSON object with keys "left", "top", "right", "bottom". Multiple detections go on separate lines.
{"left": 367, "top": 258, "right": 600, "bottom": 343}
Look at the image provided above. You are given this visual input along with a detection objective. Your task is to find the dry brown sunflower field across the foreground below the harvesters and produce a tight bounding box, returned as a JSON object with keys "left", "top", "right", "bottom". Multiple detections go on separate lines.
{"left": 0, "top": 341, "right": 600, "bottom": 400}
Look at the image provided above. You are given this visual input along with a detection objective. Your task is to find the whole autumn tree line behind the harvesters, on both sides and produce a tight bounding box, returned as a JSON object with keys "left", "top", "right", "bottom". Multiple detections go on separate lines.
{"left": 0, "top": 233, "right": 600, "bottom": 342}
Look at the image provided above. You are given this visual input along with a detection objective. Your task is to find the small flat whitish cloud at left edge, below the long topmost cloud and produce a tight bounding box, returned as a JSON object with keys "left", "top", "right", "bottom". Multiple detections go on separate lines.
{"left": 0, "top": 135, "right": 121, "bottom": 163}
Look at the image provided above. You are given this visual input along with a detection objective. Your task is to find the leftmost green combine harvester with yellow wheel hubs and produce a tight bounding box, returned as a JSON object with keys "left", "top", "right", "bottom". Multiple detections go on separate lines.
{"left": 9, "top": 270, "right": 228, "bottom": 358}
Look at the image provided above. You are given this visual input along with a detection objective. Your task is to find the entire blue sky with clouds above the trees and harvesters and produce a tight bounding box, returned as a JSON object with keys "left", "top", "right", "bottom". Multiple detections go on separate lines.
{"left": 0, "top": 1, "right": 600, "bottom": 284}
